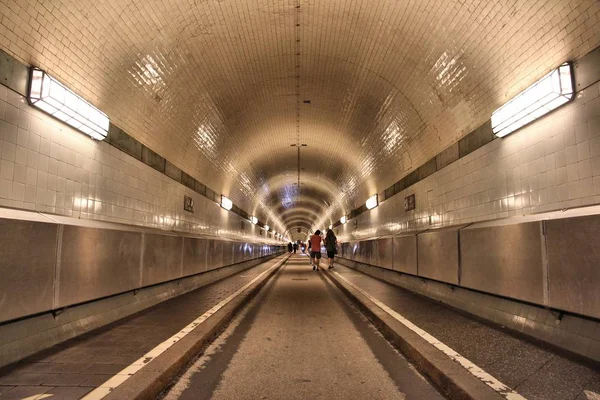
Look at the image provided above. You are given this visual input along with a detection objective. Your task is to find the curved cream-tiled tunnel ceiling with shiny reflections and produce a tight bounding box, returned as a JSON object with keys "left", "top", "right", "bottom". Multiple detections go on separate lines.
{"left": 0, "top": 0, "right": 600, "bottom": 231}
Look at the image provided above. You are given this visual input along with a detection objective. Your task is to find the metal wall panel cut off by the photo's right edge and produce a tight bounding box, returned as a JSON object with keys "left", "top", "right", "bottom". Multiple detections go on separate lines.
{"left": 546, "top": 215, "right": 600, "bottom": 318}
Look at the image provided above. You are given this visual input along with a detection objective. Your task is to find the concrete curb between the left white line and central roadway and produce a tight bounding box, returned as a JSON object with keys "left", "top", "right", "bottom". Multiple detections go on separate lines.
{"left": 104, "top": 255, "right": 289, "bottom": 400}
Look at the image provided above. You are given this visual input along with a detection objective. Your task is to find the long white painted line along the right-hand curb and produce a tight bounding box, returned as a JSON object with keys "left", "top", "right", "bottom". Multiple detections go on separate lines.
{"left": 333, "top": 271, "right": 526, "bottom": 400}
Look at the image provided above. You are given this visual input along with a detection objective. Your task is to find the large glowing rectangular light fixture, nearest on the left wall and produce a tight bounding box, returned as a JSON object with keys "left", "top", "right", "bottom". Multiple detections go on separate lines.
{"left": 27, "top": 68, "right": 109, "bottom": 140}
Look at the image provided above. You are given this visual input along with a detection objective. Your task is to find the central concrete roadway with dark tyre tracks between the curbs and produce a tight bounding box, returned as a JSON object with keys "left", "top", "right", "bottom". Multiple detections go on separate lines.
{"left": 164, "top": 255, "right": 443, "bottom": 400}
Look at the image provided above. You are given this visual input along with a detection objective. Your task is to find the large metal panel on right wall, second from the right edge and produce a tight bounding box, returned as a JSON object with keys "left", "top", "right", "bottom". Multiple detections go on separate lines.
{"left": 460, "top": 221, "right": 544, "bottom": 304}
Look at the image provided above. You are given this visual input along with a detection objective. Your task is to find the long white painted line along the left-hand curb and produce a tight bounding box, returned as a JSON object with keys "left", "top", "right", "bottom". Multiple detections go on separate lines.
{"left": 82, "top": 258, "right": 287, "bottom": 400}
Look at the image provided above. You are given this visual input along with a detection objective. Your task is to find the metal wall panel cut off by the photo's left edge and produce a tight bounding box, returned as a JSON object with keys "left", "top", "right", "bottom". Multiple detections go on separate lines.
{"left": 0, "top": 219, "right": 58, "bottom": 322}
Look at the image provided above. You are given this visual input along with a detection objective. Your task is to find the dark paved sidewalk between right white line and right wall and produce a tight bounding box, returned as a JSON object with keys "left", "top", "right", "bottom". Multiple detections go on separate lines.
{"left": 331, "top": 264, "right": 600, "bottom": 400}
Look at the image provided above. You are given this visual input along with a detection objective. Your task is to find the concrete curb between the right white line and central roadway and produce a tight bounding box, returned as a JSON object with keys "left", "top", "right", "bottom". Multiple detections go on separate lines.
{"left": 321, "top": 268, "right": 505, "bottom": 400}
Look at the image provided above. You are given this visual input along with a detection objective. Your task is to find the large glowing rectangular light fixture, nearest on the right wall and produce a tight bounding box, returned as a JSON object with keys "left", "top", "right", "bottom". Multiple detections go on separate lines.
{"left": 492, "top": 63, "right": 573, "bottom": 137}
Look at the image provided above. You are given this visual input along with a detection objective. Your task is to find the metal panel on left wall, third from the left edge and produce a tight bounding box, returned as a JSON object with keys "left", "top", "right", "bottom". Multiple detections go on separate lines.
{"left": 142, "top": 234, "right": 183, "bottom": 286}
